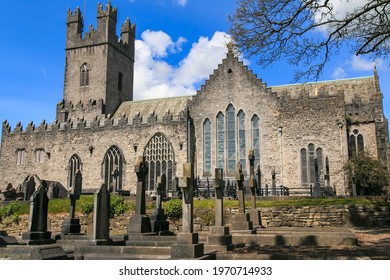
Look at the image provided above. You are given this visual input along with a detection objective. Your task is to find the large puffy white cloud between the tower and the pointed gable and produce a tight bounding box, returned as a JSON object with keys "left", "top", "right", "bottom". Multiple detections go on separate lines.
{"left": 134, "top": 30, "right": 229, "bottom": 100}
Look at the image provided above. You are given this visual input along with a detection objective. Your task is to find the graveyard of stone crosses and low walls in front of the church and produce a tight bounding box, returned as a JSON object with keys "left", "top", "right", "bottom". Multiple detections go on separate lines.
{"left": 0, "top": 151, "right": 390, "bottom": 260}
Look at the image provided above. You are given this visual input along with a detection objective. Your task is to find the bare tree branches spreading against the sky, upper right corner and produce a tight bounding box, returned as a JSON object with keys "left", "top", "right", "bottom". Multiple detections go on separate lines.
{"left": 229, "top": 0, "right": 390, "bottom": 80}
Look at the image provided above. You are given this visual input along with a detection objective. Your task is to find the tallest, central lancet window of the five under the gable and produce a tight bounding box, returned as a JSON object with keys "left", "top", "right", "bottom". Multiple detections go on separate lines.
{"left": 226, "top": 104, "right": 236, "bottom": 173}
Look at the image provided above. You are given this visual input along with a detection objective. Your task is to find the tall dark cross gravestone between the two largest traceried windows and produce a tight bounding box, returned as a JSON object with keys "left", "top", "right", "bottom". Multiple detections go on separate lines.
{"left": 127, "top": 156, "right": 152, "bottom": 234}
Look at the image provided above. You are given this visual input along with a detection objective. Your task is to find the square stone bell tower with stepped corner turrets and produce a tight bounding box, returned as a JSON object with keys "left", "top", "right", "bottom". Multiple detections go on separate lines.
{"left": 57, "top": 1, "right": 135, "bottom": 121}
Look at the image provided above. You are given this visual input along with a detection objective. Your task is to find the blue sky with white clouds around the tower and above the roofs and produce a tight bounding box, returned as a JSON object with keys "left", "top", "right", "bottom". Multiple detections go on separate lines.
{"left": 0, "top": 0, "right": 390, "bottom": 132}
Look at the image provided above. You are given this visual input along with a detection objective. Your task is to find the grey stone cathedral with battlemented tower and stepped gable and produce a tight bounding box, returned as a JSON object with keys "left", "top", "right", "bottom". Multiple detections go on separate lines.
{"left": 0, "top": 2, "right": 389, "bottom": 198}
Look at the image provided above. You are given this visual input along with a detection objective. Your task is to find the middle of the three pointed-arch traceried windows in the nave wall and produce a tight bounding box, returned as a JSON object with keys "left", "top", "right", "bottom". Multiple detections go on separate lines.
{"left": 103, "top": 146, "right": 125, "bottom": 190}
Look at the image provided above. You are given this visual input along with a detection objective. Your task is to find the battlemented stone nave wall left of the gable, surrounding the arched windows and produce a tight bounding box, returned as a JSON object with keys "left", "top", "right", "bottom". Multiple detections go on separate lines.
{"left": 0, "top": 119, "right": 187, "bottom": 193}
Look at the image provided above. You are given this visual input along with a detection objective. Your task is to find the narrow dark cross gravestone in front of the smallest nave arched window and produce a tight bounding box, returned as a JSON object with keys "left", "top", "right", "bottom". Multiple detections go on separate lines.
{"left": 62, "top": 170, "right": 83, "bottom": 235}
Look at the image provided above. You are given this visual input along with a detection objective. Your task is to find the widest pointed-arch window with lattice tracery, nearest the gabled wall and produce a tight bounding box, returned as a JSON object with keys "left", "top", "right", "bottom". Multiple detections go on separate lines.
{"left": 144, "top": 133, "right": 175, "bottom": 193}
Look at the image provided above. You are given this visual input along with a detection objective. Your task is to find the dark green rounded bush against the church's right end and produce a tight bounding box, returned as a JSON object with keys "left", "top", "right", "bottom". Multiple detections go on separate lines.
{"left": 344, "top": 154, "right": 390, "bottom": 195}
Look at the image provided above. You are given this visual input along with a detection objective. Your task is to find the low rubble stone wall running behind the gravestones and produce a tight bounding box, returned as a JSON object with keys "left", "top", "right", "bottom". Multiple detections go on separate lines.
{"left": 0, "top": 205, "right": 390, "bottom": 236}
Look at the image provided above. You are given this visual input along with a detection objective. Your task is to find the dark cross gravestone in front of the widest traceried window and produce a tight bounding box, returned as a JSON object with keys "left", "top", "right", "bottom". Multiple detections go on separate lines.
{"left": 150, "top": 174, "right": 172, "bottom": 235}
